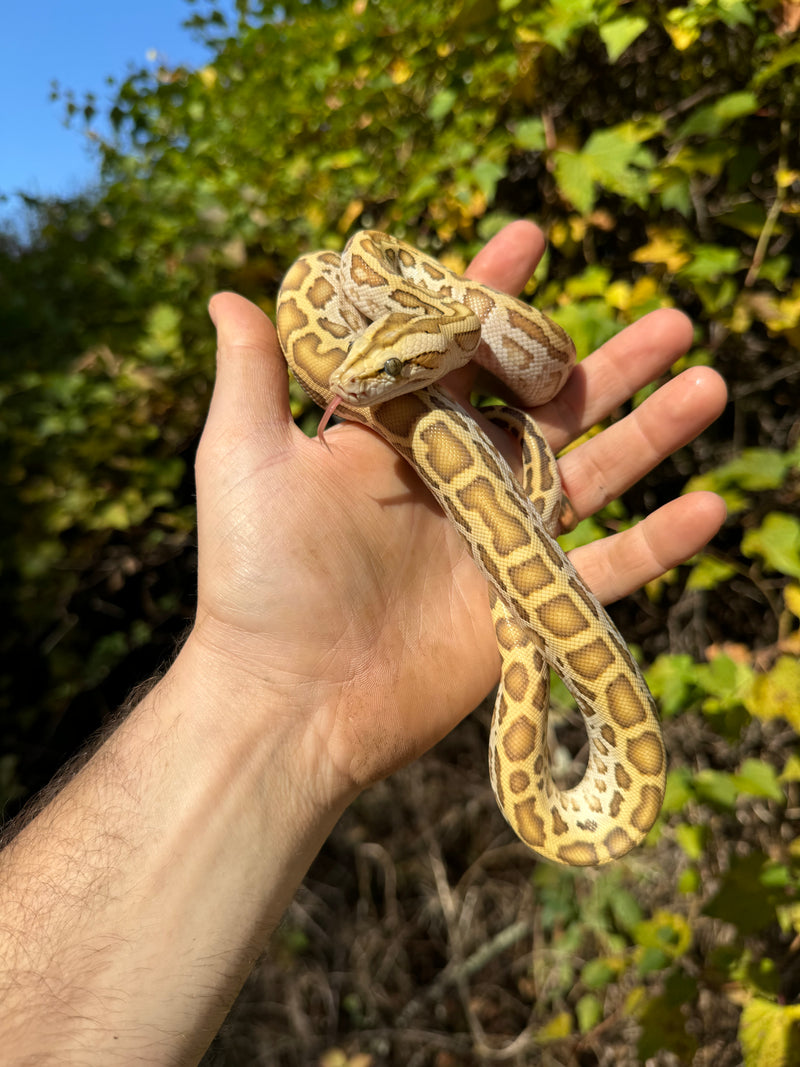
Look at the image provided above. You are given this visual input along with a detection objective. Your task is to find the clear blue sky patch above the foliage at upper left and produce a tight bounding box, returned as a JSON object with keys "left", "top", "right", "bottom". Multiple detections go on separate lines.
{"left": 0, "top": 0, "right": 229, "bottom": 227}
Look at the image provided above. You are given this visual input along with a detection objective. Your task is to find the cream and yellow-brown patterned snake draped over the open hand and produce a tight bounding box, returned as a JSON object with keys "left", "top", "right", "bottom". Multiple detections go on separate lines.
{"left": 277, "top": 232, "right": 666, "bottom": 865}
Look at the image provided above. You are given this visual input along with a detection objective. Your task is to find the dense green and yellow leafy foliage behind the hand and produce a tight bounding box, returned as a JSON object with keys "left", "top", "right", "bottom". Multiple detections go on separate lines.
{"left": 0, "top": 0, "right": 800, "bottom": 1067}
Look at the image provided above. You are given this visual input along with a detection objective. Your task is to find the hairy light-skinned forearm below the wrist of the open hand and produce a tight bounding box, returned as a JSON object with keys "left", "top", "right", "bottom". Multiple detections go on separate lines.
{"left": 0, "top": 642, "right": 343, "bottom": 1065}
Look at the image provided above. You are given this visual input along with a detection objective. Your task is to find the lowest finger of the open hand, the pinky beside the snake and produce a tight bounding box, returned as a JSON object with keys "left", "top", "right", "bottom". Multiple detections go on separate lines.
{"left": 570, "top": 492, "right": 726, "bottom": 604}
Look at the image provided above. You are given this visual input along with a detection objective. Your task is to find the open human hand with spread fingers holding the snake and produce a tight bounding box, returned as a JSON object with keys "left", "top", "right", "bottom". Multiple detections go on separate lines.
{"left": 190, "top": 223, "right": 725, "bottom": 794}
